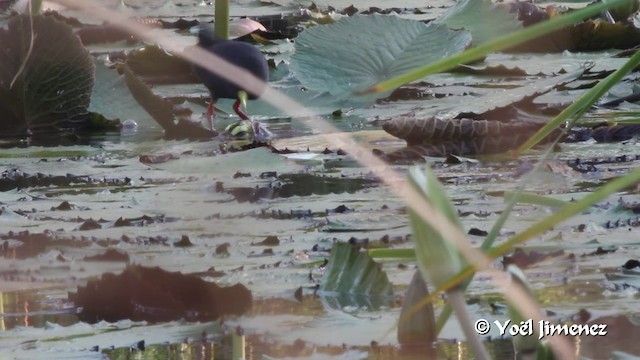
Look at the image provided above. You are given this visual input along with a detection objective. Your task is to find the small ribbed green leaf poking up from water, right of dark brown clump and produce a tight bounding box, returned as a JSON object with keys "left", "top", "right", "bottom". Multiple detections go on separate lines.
{"left": 320, "top": 243, "right": 392, "bottom": 296}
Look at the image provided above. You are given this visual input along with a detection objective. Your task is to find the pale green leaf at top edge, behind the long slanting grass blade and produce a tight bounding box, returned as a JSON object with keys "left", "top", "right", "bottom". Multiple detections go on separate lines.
{"left": 434, "top": 0, "right": 522, "bottom": 45}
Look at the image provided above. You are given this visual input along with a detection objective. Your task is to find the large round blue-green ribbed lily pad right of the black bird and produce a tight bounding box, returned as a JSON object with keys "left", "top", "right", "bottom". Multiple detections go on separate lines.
{"left": 291, "top": 15, "right": 471, "bottom": 101}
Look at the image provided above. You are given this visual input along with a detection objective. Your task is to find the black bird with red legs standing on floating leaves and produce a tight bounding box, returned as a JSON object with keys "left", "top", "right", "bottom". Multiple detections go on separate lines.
{"left": 195, "top": 26, "right": 269, "bottom": 136}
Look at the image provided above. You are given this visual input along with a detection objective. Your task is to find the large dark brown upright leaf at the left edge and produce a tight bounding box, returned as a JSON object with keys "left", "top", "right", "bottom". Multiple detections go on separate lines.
{"left": 0, "top": 15, "right": 94, "bottom": 136}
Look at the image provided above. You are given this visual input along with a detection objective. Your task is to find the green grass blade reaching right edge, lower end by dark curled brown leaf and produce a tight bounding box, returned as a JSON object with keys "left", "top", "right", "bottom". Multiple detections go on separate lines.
{"left": 516, "top": 51, "right": 640, "bottom": 154}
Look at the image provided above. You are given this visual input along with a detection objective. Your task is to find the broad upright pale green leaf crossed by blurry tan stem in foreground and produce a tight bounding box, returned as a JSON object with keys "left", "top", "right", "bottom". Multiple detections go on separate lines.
{"left": 408, "top": 167, "right": 463, "bottom": 287}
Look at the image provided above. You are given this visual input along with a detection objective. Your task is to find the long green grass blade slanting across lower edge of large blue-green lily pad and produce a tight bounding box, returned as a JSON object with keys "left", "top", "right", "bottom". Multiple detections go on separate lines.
{"left": 356, "top": 0, "right": 635, "bottom": 94}
